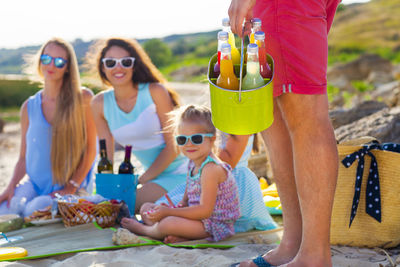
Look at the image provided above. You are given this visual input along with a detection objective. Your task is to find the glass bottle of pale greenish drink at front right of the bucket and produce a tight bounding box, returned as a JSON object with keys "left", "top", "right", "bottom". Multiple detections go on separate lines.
{"left": 242, "top": 44, "right": 265, "bottom": 90}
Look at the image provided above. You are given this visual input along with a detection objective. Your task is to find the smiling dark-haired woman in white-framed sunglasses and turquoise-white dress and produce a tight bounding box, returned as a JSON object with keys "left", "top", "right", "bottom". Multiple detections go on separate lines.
{"left": 88, "top": 38, "right": 187, "bottom": 214}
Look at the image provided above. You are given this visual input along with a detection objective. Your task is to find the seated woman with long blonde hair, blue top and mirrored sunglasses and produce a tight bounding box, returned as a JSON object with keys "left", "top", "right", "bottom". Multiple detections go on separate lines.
{"left": 0, "top": 38, "right": 96, "bottom": 216}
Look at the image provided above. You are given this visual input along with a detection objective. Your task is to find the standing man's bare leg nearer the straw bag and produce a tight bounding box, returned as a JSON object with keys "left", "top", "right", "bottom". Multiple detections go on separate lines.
{"left": 275, "top": 94, "right": 338, "bottom": 267}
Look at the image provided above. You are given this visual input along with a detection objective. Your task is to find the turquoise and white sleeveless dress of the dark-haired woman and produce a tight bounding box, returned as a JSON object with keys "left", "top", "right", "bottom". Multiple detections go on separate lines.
{"left": 103, "top": 83, "right": 188, "bottom": 191}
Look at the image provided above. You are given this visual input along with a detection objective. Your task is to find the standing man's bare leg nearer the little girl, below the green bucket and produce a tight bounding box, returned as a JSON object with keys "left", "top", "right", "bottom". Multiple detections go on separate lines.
{"left": 240, "top": 101, "right": 302, "bottom": 266}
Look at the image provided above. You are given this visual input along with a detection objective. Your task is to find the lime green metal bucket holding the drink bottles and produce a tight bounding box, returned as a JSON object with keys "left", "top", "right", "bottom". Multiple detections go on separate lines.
{"left": 208, "top": 51, "right": 274, "bottom": 135}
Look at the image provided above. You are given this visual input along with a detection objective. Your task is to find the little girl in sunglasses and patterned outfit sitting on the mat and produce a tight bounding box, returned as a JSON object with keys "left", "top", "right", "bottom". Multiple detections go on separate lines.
{"left": 121, "top": 105, "right": 240, "bottom": 241}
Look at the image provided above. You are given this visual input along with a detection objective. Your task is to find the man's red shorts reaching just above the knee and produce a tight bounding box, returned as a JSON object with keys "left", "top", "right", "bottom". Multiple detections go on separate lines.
{"left": 253, "top": 0, "right": 340, "bottom": 96}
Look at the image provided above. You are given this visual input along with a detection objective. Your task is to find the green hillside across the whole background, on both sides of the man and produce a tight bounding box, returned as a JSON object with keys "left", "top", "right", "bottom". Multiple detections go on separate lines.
{"left": 0, "top": 0, "right": 400, "bottom": 76}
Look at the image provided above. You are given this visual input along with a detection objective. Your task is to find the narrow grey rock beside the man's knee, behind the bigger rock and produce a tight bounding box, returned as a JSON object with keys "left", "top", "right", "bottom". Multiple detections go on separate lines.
{"left": 329, "top": 100, "right": 388, "bottom": 129}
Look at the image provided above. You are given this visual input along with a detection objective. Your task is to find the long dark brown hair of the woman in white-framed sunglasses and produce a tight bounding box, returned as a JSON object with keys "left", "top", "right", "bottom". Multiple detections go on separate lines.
{"left": 85, "top": 38, "right": 180, "bottom": 107}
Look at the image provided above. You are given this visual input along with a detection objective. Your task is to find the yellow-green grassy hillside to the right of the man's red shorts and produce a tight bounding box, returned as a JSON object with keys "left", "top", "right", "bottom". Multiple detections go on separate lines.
{"left": 329, "top": 0, "right": 400, "bottom": 58}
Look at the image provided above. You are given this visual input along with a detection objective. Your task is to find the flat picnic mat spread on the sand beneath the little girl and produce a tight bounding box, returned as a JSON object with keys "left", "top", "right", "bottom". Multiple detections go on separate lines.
{"left": 0, "top": 223, "right": 282, "bottom": 261}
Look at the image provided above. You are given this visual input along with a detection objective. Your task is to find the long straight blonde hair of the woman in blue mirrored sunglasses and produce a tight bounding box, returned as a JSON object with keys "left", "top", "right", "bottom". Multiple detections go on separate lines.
{"left": 27, "top": 38, "right": 87, "bottom": 185}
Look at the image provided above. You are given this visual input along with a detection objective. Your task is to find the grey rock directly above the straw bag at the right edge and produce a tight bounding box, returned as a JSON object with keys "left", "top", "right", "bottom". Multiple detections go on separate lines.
{"left": 335, "top": 107, "right": 400, "bottom": 143}
